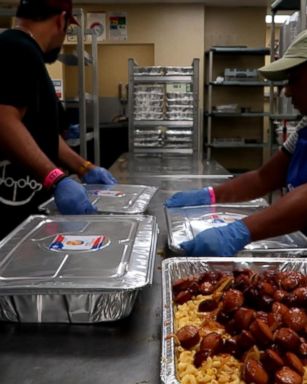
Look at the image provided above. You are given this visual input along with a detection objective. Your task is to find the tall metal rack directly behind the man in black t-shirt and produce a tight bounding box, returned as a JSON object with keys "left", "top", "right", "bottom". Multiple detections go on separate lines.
{"left": 61, "top": 8, "right": 100, "bottom": 165}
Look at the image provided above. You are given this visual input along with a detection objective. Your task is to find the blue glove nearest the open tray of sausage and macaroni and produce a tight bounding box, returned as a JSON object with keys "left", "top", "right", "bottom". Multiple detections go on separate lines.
{"left": 180, "top": 220, "right": 251, "bottom": 256}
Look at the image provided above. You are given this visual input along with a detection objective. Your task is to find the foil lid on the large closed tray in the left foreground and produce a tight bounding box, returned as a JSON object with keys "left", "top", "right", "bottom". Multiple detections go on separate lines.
{"left": 0, "top": 215, "right": 158, "bottom": 295}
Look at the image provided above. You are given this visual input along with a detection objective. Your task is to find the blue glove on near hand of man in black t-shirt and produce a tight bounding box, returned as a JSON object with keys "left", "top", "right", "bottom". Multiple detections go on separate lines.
{"left": 54, "top": 177, "right": 97, "bottom": 215}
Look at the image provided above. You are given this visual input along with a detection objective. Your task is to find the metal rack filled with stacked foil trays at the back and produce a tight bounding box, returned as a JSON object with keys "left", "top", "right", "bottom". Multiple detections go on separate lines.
{"left": 128, "top": 59, "right": 202, "bottom": 157}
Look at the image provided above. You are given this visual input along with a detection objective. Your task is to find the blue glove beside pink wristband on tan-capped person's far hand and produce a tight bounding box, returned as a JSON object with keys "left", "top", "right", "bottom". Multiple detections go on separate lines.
{"left": 165, "top": 188, "right": 212, "bottom": 208}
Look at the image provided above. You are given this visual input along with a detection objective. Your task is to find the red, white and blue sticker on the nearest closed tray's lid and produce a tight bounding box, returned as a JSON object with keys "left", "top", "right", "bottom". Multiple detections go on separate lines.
{"left": 49, "top": 234, "right": 110, "bottom": 251}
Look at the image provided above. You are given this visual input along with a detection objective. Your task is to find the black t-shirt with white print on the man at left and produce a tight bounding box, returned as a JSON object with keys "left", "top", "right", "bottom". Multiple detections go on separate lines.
{"left": 0, "top": 29, "right": 64, "bottom": 237}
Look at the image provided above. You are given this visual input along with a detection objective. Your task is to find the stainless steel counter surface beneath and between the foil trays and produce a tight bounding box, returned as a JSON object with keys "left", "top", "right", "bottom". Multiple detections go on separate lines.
{"left": 0, "top": 155, "right": 229, "bottom": 384}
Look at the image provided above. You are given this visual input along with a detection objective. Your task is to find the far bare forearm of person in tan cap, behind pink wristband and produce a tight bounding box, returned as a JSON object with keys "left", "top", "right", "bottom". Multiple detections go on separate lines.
{"left": 214, "top": 150, "right": 291, "bottom": 203}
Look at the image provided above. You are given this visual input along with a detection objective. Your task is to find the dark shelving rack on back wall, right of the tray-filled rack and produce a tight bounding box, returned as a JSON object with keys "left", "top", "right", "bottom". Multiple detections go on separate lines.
{"left": 205, "top": 47, "right": 270, "bottom": 160}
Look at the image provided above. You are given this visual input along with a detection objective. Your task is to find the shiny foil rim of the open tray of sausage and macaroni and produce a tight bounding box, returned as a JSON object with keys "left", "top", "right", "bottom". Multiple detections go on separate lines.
{"left": 160, "top": 253, "right": 307, "bottom": 384}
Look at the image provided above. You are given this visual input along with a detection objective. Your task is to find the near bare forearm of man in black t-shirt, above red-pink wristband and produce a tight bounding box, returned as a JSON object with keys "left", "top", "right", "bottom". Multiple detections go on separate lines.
{"left": 0, "top": 105, "right": 56, "bottom": 181}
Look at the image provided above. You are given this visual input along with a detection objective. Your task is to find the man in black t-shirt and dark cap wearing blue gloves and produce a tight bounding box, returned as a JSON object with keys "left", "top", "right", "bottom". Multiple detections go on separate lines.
{"left": 0, "top": 0, "right": 116, "bottom": 238}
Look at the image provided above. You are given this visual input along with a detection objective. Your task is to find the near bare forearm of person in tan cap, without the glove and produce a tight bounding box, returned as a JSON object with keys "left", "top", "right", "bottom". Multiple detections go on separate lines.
{"left": 243, "top": 184, "right": 307, "bottom": 241}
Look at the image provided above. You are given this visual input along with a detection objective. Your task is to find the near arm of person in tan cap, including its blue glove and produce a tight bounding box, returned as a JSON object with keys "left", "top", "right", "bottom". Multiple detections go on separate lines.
{"left": 180, "top": 183, "right": 307, "bottom": 256}
